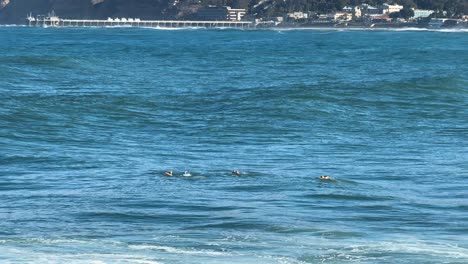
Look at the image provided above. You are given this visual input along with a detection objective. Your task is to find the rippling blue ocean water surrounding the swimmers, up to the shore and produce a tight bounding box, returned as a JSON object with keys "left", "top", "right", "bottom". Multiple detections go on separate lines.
{"left": 0, "top": 27, "right": 468, "bottom": 264}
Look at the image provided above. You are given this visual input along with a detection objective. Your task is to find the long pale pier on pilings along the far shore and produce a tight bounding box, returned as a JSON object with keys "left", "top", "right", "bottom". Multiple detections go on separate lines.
{"left": 26, "top": 15, "right": 255, "bottom": 29}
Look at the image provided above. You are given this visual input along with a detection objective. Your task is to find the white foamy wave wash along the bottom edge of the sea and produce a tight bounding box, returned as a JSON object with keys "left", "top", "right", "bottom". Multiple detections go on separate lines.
{"left": 0, "top": 238, "right": 468, "bottom": 264}
